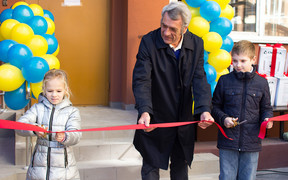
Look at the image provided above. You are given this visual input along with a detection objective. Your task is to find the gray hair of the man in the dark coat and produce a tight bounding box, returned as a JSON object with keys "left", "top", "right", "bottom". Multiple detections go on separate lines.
{"left": 161, "top": 1, "right": 192, "bottom": 27}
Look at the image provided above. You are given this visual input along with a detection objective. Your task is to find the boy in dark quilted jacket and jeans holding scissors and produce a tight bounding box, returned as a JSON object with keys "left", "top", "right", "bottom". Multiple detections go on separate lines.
{"left": 212, "top": 40, "right": 273, "bottom": 180}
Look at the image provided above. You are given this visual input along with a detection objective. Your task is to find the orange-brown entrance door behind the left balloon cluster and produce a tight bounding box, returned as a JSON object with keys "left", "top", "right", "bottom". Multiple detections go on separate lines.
{"left": 30, "top": 0, "right": 110, "bottom": 105}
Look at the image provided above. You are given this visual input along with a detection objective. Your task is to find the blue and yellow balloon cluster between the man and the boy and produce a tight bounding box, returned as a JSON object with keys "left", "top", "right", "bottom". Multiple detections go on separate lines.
{"left": 184, "top": 0, "right": 234, "bottom": 94}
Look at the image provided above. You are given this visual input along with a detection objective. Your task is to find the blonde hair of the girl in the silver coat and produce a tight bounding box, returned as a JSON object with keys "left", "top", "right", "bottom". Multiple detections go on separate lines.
{"left": 42, "top": 69, "right": 72, "bottom": 99}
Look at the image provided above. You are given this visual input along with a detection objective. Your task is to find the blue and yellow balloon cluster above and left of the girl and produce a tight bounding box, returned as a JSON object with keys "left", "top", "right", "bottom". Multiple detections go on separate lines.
{"left": 0, "top": 1, "right": 60, "bottom": 110}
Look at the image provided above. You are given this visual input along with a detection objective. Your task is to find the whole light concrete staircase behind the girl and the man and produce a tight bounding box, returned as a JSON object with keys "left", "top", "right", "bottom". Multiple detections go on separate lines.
{"left": 0, "top": 106, "right": 219, "bottom": 180}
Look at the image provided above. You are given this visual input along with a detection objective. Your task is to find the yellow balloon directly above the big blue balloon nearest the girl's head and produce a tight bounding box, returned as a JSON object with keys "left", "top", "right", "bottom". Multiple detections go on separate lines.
{"left": 25, "top": 35, "right": 48, "bottom": 56}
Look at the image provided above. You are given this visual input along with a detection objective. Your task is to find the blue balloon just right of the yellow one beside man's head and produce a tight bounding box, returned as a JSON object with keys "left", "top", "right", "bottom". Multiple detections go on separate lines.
{"left": 209, "top": 17, "right": 232, "bottom": 37}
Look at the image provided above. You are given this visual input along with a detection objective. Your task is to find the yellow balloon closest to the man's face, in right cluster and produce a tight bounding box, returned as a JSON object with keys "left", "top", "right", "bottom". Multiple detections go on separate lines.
{"left": 188, "top": 16, "right": 210, "bottom": 37}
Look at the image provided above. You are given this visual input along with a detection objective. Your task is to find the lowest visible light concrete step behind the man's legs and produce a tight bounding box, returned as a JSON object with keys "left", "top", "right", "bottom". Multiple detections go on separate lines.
{"left": 78, "top": 153, "right": 219, "bottom": 180}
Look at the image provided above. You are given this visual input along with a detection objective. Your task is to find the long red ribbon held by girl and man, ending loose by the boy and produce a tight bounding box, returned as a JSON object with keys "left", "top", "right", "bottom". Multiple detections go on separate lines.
{"left": 0, "top": 119, "right": 233, "bottom": 140}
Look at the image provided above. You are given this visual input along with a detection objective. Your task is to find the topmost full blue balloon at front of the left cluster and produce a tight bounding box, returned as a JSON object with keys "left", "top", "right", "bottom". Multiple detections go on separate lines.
{"left": 12, "top": 5, "right": 34, "bottom": 23}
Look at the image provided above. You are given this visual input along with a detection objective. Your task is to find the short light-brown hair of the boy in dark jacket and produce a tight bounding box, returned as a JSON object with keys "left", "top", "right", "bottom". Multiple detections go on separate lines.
{"left": 231, "top": 40, "right": 255, "bottom": 59}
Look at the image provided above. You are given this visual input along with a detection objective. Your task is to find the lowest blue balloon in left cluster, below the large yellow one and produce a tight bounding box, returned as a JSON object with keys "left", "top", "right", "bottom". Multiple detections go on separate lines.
{"left": 4, "top": 82, "right": 29, "bottom": 110}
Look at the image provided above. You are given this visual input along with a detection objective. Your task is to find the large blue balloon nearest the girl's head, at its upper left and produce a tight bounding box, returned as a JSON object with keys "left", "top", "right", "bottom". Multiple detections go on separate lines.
{"left": 22, "top": 56, "right": 49, "bottom": 83}
